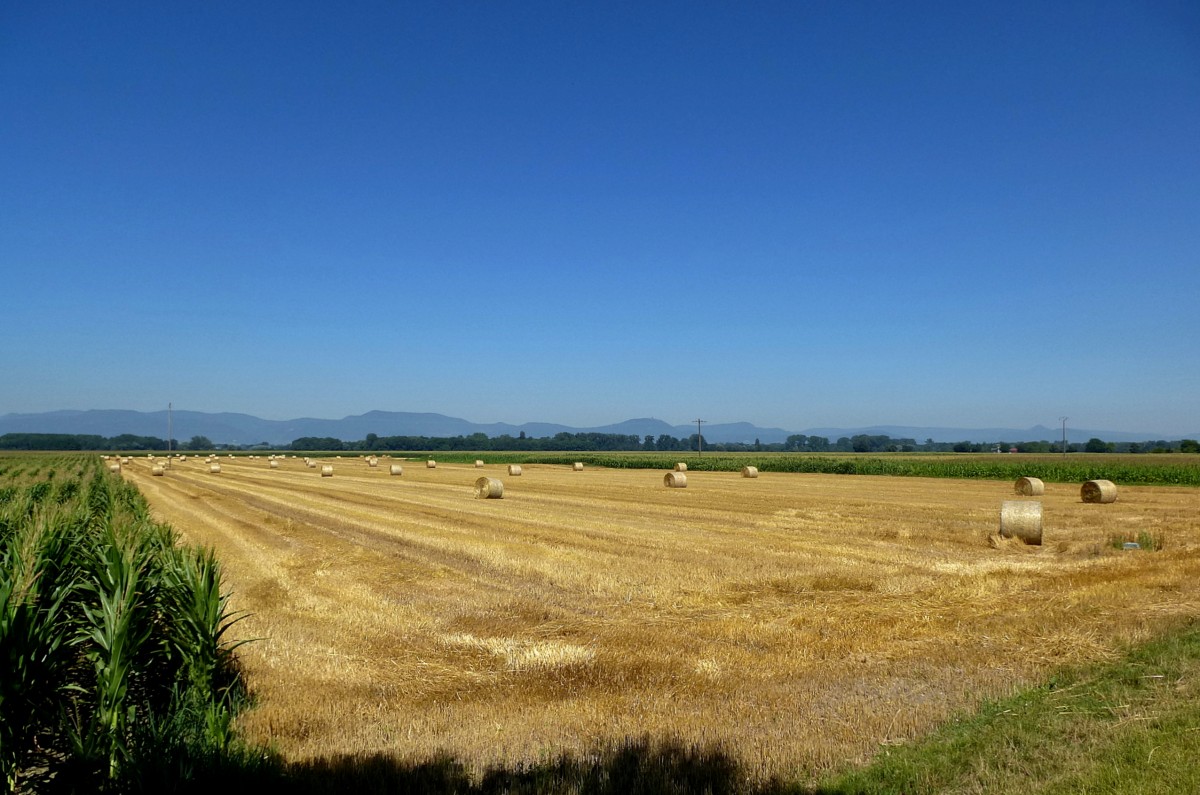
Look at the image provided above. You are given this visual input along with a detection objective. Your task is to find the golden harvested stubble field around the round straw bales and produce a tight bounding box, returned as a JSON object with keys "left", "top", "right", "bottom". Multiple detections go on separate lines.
{"left": 125, "top": 456, "right": 1200, "bottom": 777}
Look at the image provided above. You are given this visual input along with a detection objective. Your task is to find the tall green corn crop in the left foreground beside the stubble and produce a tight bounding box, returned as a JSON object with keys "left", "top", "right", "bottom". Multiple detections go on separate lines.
{"left": 0, "top": 455, "right": 259, "bottom": 791}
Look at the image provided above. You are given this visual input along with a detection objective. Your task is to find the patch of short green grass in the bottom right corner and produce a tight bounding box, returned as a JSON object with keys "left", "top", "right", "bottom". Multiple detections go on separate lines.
{"left": 806, "top": 621, "right": 1200, "bottom": 795}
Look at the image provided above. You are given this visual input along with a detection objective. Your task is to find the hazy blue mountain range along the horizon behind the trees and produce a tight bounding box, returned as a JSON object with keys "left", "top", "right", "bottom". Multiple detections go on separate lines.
{"left": 0, "top": 410, "right": 1200, "bottom": 447}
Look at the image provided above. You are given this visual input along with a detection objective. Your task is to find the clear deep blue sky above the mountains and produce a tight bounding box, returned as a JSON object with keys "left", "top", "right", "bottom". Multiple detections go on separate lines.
{"left": 0, "top": 0, "right": 1200, "bottom": 436}
